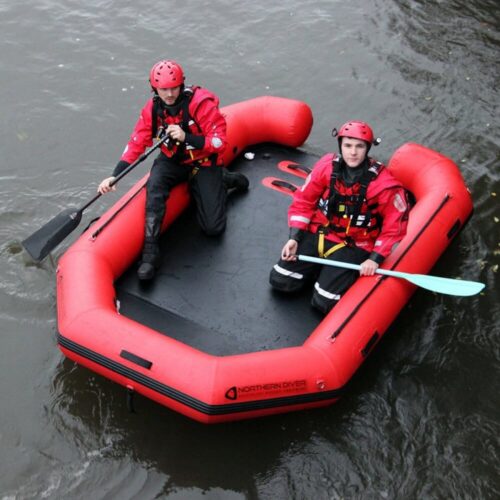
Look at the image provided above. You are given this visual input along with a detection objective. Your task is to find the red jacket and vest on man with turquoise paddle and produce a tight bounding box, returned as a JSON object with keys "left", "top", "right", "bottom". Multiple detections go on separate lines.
{"left": 288, "top": 154, "right": 408, "bottom": 257}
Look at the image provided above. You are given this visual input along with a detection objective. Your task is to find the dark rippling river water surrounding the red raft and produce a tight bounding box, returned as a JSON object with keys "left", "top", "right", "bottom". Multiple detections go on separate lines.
{"left": 0, "top": 0, "right": 500, "bottom": 500}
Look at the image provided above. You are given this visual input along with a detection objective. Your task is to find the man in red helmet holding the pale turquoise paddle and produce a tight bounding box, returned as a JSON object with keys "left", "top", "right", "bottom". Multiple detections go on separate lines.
{"left": 270, "top": 121, "right": 409, "bottom": 314}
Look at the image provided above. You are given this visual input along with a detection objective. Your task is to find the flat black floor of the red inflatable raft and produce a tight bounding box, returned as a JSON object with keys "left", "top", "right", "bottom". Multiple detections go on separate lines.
{"left": 116, "top": 144, "right": 321, "bottom": 355}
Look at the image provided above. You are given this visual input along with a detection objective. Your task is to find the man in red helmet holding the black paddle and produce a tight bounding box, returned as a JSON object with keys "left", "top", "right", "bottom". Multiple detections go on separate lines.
{"left": 97, "top": 60, "right": 248, "bottom": 280}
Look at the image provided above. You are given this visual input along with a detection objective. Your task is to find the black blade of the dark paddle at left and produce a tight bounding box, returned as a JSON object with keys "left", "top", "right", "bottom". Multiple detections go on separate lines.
{"left": 21, "top": 208, "right": 82, "bottom": 262}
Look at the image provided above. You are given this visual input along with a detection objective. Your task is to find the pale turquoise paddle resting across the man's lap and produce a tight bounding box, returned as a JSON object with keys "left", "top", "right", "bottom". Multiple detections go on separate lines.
{"left": 297, "top": 255, "right": 485, "bottom": 297}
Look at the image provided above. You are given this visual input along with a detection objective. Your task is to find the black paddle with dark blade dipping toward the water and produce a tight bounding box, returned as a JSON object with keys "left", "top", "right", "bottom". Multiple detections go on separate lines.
{"left": 21, "top": 135, "right": 169, "bottom": 262}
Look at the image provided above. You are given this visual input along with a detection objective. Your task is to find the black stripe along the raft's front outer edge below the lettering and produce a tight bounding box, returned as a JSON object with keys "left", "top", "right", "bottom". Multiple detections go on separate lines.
{"left": 57, "top": 333, "right": 344, "bottom": 415}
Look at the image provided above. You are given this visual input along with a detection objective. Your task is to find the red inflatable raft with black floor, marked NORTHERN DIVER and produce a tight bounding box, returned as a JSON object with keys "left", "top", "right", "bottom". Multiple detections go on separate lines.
{"left": 57, "top": 96, "right": 472, "bottom": 423}
